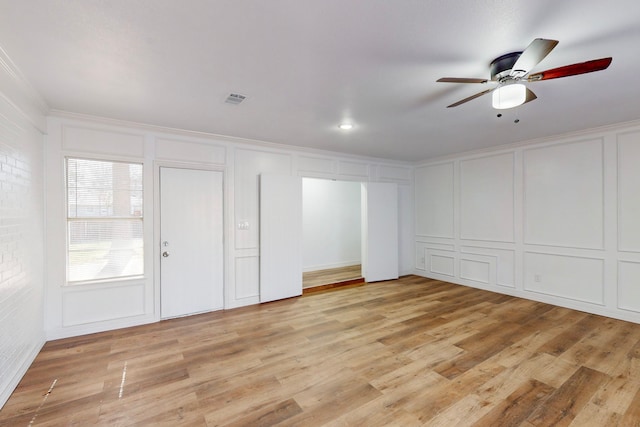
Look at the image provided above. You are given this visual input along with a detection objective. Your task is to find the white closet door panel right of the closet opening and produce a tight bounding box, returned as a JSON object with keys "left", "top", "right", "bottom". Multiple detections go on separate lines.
{"left": 361, "top": 182, "right": 399, "bottom": 282}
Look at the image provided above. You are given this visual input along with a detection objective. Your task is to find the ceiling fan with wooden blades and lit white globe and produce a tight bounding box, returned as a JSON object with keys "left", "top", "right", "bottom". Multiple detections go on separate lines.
{"left": 437, "top": 39, "right": 613, "bottom": 109}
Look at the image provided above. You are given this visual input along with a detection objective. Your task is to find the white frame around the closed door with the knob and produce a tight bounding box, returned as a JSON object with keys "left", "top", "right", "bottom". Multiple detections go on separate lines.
{"left": 153, "top": 160, "right": 231, "bottom": 321}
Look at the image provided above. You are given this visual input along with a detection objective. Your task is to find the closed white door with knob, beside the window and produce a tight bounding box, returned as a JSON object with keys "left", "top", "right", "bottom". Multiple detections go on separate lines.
{"left": 160, "top": 167, "right": 224, "bottom": 318}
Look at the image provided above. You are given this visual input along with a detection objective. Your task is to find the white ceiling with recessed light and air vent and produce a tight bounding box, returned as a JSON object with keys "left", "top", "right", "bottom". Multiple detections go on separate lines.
{"left": 0, "top": 0, "right": 640, "bottom": 161}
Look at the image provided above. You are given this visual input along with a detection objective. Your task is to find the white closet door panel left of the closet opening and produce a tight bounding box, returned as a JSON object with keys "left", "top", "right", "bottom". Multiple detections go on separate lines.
{"left": 260, "top": 174, "right": 302, "bottom": 302}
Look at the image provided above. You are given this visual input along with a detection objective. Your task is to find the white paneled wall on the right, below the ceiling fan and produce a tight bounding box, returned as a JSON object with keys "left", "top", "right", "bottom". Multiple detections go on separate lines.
{"left": 415, "top": 123, "right": 640, "bottom": 323}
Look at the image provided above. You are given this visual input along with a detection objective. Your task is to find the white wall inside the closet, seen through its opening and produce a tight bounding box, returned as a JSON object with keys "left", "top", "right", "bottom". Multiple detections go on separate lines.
{"left": 302, "top": 178, "right": 360, "bottom": 271}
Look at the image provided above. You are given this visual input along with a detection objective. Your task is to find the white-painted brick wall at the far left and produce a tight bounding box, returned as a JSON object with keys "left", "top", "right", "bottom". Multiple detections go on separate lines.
{"left": 0, "top": 49, "right": 46, "bottom": 407}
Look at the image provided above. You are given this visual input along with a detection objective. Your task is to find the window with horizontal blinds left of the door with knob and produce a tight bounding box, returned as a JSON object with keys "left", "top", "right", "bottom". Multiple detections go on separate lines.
{"left": 66, "top": 158, "right": 144, "bottom": 283}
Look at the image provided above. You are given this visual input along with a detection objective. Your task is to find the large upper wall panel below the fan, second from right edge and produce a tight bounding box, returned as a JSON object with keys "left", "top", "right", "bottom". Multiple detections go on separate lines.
{"left": 523, "top": 137, "right": 604, "bottom": 249}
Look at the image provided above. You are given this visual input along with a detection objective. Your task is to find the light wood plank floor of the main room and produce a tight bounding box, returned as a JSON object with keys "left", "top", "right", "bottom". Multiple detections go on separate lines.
{"left": 0, "top": 276, "right": 640, "bottom": 427}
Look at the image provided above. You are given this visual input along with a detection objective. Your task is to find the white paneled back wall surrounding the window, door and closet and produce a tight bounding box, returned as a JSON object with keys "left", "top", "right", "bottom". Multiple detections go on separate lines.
{"left": 45, "top": 113, "right": 413, "bottom": 339}
